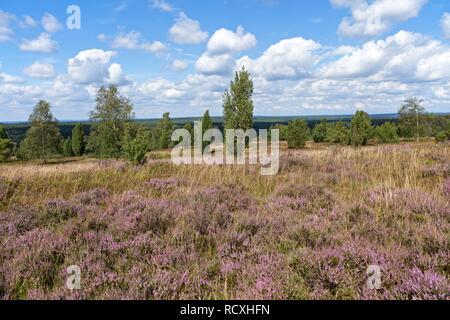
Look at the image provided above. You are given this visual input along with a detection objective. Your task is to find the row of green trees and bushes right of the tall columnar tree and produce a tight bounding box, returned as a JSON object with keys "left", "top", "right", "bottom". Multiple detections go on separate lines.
{"left": 275, "top": 98, "right": 450, "bottom": 148}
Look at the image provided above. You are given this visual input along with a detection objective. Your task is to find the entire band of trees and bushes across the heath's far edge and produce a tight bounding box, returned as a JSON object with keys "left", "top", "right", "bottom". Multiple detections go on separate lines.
{"left": 0, "top": 68, "right": 450, "bottom": 164}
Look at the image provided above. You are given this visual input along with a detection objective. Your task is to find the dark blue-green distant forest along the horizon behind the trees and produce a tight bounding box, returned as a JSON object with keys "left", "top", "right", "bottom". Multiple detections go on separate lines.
{"left": 0, "top": 114, "right": 442, "bottom": 142}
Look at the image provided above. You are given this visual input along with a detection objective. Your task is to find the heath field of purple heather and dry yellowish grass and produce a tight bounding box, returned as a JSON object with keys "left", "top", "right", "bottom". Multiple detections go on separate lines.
{"left": 0, "top": 142, "right": 450, "bottom": 299}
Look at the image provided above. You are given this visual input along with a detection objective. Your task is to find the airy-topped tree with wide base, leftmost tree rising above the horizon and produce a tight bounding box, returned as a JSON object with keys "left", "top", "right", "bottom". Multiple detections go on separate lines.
{"left": 20, "top": 100, "right": 62, "bottom": 162}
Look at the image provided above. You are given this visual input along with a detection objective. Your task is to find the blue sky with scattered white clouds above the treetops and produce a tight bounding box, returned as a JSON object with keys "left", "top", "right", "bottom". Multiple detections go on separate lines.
{"left": 0, "top": 0, "right": 450, "bottom": 122}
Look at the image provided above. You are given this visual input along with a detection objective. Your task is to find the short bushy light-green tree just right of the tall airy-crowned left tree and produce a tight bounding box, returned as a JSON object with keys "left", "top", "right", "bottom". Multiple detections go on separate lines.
{"left": 123, "top": 123, "right": 152, "bottom": 165}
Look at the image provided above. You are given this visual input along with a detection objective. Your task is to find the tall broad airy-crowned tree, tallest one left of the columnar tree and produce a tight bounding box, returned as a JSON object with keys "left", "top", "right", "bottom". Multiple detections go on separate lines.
{"left": 88, "top": 85, "right": 134, "bottom": 158}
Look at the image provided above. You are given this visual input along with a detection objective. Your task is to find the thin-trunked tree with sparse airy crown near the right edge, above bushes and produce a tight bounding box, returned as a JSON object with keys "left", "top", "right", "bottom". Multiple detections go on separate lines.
{"left": 398, "top": 97, "right": 425, "bottom": 142}
